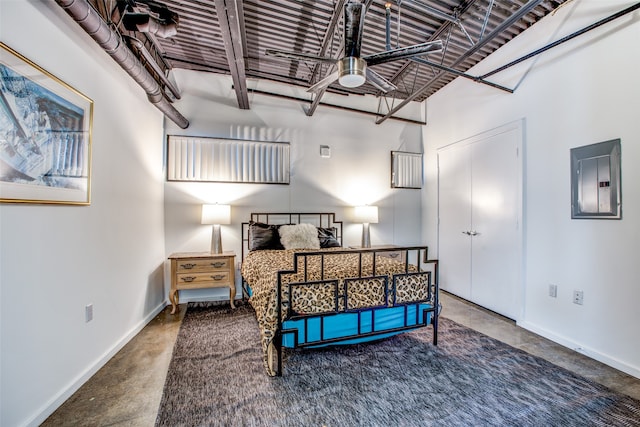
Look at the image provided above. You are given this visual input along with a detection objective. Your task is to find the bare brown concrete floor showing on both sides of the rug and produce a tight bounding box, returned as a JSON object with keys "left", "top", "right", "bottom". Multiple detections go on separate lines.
{"left": 42, "top": 292, "right": 640, "bottom": 426}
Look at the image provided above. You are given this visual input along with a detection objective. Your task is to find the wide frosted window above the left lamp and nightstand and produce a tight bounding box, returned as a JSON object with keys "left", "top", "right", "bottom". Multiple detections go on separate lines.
{"left": 167, "top": 135, "right": 289, "bottom": 184}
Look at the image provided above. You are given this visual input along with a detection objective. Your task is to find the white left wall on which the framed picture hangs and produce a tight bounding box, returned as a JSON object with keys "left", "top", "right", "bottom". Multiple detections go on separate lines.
{"left": 0, "top": 0, "right": 165, "bottom": 426}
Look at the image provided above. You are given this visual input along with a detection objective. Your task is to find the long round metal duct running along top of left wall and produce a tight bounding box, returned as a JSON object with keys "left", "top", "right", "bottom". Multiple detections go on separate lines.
{"left": 56, "top": 0, "right": 189, "bottom": 129}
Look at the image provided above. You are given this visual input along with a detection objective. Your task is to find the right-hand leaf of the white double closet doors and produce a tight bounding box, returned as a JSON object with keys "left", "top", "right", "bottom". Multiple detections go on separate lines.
{"left": 469, "top": 132, "right": 522, "bottom": 319}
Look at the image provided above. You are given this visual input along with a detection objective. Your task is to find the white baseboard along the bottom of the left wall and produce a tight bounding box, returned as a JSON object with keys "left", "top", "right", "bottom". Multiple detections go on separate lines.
{"left": 24, "top": 300, "right": 169, "bottom": 427}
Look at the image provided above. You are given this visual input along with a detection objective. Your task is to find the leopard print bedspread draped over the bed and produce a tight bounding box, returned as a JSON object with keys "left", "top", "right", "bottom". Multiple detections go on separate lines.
{"left": 242, "top": 248, "right": 428, "bottom": 376}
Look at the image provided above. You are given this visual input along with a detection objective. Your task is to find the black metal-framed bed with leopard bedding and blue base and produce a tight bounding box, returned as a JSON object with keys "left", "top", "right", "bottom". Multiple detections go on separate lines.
{"left": 241, "top": 213, "right": 439, "bottom": 376}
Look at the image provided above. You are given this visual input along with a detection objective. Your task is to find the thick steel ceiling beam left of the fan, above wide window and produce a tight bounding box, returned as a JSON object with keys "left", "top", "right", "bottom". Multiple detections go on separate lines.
{"left": 214, "top": 0, "right": 249, "bottom": 110}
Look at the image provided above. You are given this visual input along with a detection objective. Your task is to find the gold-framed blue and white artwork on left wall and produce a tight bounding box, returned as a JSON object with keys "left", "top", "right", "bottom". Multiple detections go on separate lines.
{"left": 0, "top": 42, "right": 93, "bottom": 205}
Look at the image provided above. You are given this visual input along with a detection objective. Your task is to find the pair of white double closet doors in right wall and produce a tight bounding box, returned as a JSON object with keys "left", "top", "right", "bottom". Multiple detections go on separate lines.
{"left": 438, "top": 122, "right": 522, "bottom": 319}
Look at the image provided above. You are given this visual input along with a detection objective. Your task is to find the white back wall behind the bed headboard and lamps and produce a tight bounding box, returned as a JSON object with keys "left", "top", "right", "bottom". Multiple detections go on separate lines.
{"left": 165, "top": 70, "right": 422, "bottom": 301}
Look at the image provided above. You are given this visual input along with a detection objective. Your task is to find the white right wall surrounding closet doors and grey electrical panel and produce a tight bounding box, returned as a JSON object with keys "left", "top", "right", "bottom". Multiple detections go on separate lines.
{"left": 423, "top": 0, "right": 640, "bottom": 377}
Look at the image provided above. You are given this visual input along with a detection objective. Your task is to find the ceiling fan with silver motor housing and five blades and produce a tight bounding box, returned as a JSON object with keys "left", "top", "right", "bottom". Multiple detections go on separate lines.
{"left": 265, "top": 1, "right": 442, "bottom": 93}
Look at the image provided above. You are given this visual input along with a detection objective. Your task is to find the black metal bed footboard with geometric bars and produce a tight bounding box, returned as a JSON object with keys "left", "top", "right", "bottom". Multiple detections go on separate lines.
{"left": 274, "top": 246, "right": 439, "bottom": 376}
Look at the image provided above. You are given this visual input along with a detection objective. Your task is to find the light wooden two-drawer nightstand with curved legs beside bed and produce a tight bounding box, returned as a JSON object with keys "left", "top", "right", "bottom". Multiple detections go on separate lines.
{"left": 169, "top": 251, "right": 236, "bottom": 314}
